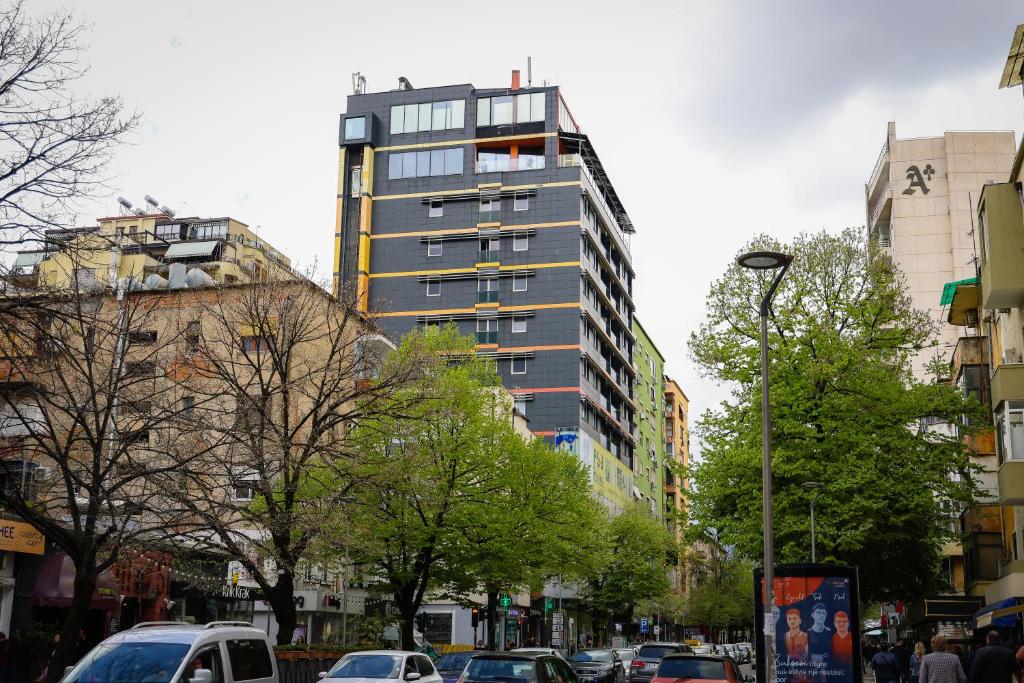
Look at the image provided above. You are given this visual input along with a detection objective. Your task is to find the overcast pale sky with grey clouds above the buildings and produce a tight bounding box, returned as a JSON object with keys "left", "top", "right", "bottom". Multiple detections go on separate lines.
{"left": 37, "top": 0, "right": 1024, "bottom": 454}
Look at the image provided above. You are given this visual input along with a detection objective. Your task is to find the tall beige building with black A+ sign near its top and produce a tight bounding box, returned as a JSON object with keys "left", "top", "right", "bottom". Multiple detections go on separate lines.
{"left": 864, "top": 122, "right": 1016, "bottom": 378}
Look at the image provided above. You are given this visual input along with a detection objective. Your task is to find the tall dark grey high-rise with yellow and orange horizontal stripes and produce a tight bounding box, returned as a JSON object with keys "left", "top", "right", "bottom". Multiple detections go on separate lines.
{"left": 335, "top": 72, "right": 635, "bottom": 507}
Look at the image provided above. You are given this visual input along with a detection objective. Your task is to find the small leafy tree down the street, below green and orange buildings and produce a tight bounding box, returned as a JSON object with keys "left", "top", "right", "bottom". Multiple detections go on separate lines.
{"left": 583, "top": 503, "right": 678, "bottom": 637}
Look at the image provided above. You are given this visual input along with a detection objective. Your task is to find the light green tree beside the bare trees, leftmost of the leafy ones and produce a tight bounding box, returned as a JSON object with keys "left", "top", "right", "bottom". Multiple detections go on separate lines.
{"left": 340, "top": 327, "right": 536, "bottom": 648}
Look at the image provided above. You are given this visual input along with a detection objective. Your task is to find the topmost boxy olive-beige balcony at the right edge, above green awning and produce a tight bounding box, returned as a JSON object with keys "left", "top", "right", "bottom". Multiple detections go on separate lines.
{"left": 978, "top": 182, "right": 1024, "bottom": 309}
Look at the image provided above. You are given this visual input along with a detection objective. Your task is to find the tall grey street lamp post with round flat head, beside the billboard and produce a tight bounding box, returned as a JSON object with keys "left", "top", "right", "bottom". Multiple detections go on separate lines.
{"left": 736, "top": 252, "right": 793, "bottom": 683}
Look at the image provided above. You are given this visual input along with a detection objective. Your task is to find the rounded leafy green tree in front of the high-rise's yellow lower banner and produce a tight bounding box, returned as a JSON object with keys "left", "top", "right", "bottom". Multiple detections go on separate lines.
{"left": 445, "top": 439, "right": 606, "bottom": 649}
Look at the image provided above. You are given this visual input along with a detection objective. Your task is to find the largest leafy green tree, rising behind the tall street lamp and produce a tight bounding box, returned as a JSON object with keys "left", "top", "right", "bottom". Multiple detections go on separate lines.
{"left": 690, "top": 228, "right": 986, "bottom": 600}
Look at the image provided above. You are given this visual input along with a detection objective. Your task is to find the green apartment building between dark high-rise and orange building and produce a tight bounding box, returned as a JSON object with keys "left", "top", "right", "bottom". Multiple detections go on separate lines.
{"left": 633, "top": 317, "right": 665, "bottom": 518}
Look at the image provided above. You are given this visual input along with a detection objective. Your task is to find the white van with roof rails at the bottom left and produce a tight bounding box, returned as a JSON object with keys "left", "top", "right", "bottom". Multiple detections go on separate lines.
{"left": 61, "top": 622, "right": 279, "bottom": 683}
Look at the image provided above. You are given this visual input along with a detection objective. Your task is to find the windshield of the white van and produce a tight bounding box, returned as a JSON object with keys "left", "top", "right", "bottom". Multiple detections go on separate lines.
{"left": 63, "top": 642, "right": 189, "bottom": 683}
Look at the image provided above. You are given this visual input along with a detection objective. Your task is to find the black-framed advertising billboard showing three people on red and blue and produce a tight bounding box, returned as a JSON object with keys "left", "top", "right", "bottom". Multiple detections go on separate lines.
{"left": 755, "top": 564, "right": 861, "bottom": 683}
